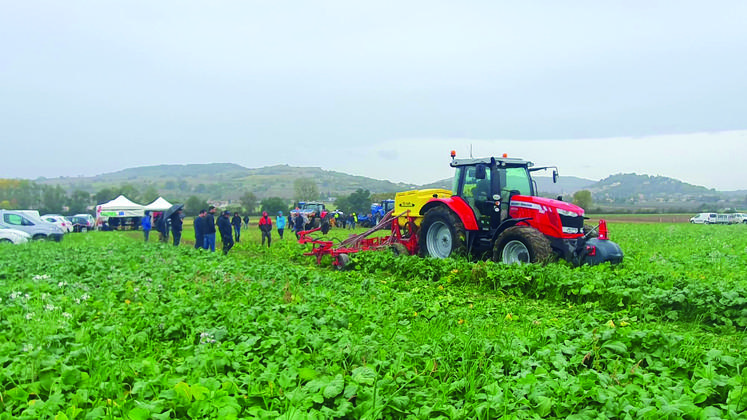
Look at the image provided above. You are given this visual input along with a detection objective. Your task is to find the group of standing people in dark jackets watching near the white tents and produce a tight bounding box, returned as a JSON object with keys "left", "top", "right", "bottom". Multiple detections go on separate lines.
{"left": 140, "top": 206, "right": 290, "bottom": 255}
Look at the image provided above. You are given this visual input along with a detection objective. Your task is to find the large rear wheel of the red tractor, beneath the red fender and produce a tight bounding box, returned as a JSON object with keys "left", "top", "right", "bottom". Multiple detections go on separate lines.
{"left": 418, "top": 207, "right": 467, "bottom": 258}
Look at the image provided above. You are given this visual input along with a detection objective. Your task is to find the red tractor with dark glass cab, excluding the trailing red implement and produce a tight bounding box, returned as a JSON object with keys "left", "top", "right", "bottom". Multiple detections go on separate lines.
{"left": 418, "top": 152, "right": 623, "bottom": 265}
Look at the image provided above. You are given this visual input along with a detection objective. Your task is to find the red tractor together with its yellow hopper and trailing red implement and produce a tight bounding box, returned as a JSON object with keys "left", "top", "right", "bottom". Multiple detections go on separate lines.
{"left": 299, "top": 151, "right": 623, "bottom": 267}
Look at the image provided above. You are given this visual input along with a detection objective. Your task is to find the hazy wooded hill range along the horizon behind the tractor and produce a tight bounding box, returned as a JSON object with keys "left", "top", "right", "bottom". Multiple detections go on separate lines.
{"left": 36, "top": 163, "right": 747, "bottom": 211}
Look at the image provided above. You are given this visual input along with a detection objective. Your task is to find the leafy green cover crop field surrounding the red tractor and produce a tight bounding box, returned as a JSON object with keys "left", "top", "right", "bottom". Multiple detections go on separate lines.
{"left": 0, "top": 223, "right": 747, "bottom": 419}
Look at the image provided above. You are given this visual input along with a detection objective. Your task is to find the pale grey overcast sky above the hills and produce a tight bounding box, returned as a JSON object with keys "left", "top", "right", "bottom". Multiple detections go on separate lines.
{"left": 0, "top": 0, "right": 747, "bottom": 190}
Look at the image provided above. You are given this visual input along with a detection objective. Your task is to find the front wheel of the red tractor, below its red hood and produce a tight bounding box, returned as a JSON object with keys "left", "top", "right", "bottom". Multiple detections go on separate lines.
{"left": 493, "top": 226, "right": 553, "bottom": 264}
